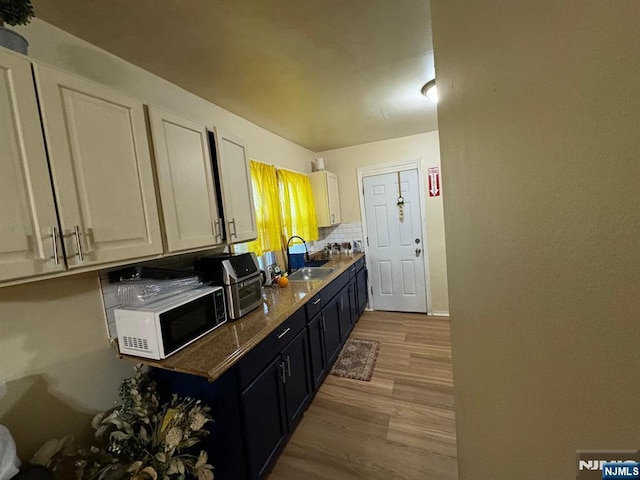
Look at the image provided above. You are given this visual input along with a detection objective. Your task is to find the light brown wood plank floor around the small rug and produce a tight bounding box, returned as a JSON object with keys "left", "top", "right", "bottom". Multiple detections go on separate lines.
{"left": 269, "top": 312, "right": 458, "bottom": 480}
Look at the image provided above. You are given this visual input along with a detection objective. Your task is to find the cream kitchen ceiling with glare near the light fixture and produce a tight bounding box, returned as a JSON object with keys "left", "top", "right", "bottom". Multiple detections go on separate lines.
{"left": 33, "top": 0, "right": 437, "bottom": 152}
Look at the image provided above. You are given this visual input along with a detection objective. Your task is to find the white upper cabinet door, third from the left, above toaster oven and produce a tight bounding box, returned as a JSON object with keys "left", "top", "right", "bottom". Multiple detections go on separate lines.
{"left": 148, "top": 106, "right": 222, "bottom": 252}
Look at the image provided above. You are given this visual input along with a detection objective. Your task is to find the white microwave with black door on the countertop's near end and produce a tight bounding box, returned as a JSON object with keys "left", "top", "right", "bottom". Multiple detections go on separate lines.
{"left": 114, "top": 287, "right": 227, "bottom": 360}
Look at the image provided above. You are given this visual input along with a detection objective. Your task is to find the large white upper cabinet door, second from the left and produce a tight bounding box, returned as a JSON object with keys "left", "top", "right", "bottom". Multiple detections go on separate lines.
{"left": 34, "top": 65, "right": 162, "bottom": 268}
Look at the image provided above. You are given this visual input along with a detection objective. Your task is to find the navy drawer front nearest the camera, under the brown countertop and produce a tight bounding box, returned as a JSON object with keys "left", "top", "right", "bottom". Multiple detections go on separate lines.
{"left": 237, "top": 308, "right": 307, "bottom": 387}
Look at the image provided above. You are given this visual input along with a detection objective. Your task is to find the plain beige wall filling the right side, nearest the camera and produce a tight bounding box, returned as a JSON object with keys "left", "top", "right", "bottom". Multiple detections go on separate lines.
{"left": 431, "top": 0, "right": 640, "bottom": 480}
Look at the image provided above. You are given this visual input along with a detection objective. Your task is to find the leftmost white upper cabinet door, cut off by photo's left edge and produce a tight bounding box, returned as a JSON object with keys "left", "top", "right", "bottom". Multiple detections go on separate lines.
{"left": 0, "top": 49, "right": 65, "bottom": 281}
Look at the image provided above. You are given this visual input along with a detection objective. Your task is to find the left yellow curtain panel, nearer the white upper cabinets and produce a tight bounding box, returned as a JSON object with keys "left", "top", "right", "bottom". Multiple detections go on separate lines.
{"left": 247, "top": 160, "right": 282, "bottom": 256}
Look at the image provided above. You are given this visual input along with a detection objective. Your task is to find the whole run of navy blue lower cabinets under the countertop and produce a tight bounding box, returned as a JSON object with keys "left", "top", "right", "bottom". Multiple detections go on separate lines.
{"left": 152, "top": 259, "right": 367, "bottom": 480}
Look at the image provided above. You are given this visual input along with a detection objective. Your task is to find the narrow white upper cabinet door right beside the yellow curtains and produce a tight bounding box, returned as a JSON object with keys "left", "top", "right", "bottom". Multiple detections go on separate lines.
{"left": 214, "top": 128, "right": 257, "bottom": 243}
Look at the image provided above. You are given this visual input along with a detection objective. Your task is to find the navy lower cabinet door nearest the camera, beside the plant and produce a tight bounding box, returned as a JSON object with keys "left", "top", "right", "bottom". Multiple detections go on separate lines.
{"left": 242, "top": 356, "right": 287, "bottom": 479}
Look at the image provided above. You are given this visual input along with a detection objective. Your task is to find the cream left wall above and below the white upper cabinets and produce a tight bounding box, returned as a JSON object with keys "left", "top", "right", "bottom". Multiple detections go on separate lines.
{"left": 0, "top": 19, "right": 314, "bottom": 460}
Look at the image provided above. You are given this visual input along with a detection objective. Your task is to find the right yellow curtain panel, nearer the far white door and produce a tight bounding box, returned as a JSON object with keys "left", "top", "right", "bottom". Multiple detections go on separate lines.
{"left": 278, "top": 170, "right": 318, "bottom": 243}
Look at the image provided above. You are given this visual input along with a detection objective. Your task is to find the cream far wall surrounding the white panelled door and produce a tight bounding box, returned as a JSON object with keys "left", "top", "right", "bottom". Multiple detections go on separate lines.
{"left": 317, "top": 131, "right": 449, "bottom": 314}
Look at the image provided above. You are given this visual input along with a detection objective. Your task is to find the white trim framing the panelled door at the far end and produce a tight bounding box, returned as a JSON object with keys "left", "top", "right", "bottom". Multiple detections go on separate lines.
{"left": 357, "top": 157, "right": 433, "bottom": 315}
